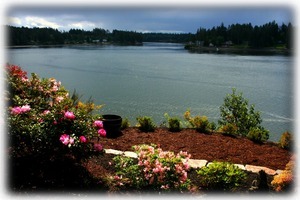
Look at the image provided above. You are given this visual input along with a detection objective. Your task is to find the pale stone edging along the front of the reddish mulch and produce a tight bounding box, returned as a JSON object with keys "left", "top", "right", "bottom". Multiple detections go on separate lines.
{"left": 104, "top": 149, "right": 282, "bottom": 176}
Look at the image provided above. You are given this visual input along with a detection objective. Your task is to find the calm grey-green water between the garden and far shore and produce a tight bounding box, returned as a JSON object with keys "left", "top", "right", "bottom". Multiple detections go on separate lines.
{"left": 7, "top": 43, "right": 294, "bottom": 141}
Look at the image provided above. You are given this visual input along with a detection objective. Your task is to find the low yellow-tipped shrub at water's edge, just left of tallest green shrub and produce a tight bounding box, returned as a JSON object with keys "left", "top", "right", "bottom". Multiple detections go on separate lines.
{"left": 184, "top": 110, "right": 211, "bottom": 133}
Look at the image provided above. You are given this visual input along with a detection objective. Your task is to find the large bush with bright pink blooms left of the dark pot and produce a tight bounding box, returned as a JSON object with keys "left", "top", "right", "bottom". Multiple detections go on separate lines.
{"left": 6, "top": 65, "right": 106, "bottom": 159}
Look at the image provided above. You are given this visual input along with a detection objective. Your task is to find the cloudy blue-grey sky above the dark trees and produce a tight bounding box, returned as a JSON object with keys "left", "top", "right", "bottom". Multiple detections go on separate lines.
{"left": 6, "top": 6, "right": 294, "bottom": 33}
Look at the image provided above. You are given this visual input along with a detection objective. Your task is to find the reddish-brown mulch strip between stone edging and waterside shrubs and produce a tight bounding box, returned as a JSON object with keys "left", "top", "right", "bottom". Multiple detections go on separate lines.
{"left": 100, "top": 128, "right": 292, "bottom": 170}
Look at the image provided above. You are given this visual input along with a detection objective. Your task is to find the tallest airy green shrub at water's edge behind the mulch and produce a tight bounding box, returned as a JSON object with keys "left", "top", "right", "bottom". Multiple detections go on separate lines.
{"left": 219, "top": 88, "right": 267, "bottom": 139}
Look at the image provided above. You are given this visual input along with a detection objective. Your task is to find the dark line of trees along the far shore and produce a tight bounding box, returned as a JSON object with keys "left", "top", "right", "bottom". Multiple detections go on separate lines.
{"left": 6, "top": 21, "right": 294, "bottom": 49}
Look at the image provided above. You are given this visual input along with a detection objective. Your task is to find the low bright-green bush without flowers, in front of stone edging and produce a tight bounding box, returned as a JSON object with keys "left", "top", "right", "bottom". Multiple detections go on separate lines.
{"left": 197, "top": 161, "right": 247, "bottom": 190}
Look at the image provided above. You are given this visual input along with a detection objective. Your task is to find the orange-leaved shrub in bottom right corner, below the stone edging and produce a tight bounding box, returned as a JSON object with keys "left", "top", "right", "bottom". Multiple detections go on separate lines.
{"left": 271, "top": 160, "right": 295, "bottom": 192}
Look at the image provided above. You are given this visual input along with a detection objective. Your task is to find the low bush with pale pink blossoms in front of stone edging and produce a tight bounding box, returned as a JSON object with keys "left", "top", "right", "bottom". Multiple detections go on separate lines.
{"left": 110, "top": 145, "right": 192, "bottom": 191}
